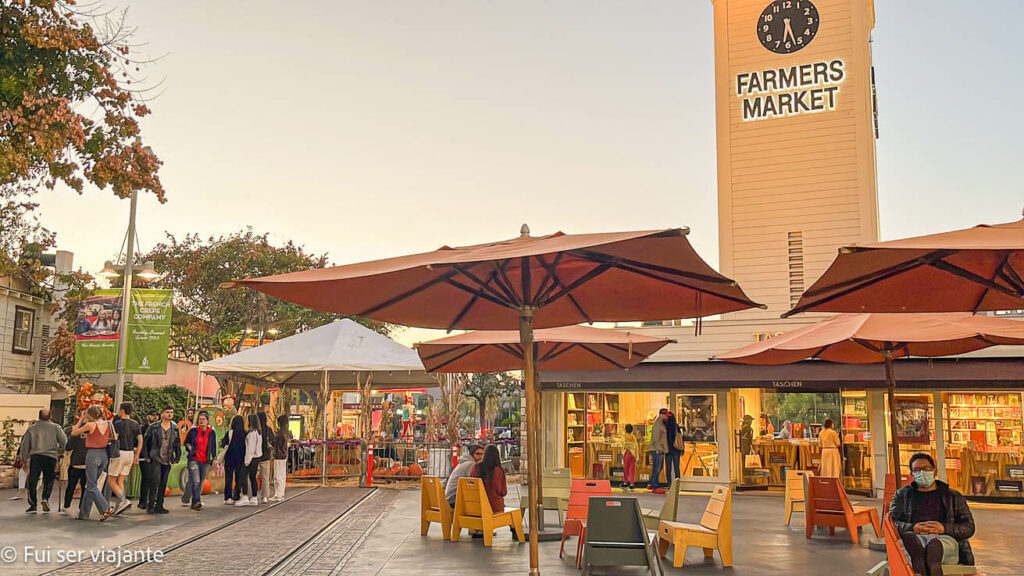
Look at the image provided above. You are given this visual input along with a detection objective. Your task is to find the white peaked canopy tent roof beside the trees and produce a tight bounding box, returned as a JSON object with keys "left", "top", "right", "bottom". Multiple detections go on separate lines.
{"left": 199, "top": 319, "right": 437, "bottom": 436}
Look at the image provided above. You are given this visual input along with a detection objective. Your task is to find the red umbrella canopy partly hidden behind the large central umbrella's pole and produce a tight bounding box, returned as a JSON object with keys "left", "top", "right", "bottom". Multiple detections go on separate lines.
{"left": 416, "top": 326, "right": 675, "bottom": 372}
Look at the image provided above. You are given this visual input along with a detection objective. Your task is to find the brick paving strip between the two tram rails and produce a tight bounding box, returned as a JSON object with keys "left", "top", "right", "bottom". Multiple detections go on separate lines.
{"left": 117, "top": 488, "right": 372, "bottom": 576}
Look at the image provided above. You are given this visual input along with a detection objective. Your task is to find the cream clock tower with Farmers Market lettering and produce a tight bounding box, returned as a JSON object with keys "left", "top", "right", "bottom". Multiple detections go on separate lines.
{"left": 713, "top": 0, "right": 879, "bottom": 317}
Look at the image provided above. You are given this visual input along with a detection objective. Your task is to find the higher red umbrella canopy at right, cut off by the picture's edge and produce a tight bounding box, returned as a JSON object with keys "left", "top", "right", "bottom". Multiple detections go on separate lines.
{"left": 782, "top": 219, "right": 1024, "bottom": 317}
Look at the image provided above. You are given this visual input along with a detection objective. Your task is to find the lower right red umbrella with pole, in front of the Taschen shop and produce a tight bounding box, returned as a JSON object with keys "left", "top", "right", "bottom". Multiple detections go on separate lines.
{"left": 713, "top": 314, "right": 1024, "bottom": 478}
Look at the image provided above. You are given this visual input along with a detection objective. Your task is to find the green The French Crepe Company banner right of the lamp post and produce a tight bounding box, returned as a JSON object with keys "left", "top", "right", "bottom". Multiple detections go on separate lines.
{"left": 125, "top": 288, "right": 173, "bottom": 374}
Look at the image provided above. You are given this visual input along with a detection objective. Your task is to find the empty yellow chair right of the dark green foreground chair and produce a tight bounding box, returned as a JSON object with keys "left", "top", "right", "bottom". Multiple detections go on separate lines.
{"left": 657, "top": 486, "right": 732, "bottom": 568}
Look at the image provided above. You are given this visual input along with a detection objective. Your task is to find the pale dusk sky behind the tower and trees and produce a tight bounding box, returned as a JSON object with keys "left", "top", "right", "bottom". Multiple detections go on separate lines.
{"left": 32, "top": 0, "right": 1024, "bottom": 340}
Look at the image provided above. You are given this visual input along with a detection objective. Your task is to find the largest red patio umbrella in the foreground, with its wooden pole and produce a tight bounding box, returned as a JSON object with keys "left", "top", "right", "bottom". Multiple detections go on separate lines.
{"left": 229, "top": 225, "right": 759, "bottom": 574}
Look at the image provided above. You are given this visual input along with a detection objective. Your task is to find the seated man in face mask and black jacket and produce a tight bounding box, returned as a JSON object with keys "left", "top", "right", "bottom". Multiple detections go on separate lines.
{"left": 889, "top": 454, "right": 974, "bottom": 576}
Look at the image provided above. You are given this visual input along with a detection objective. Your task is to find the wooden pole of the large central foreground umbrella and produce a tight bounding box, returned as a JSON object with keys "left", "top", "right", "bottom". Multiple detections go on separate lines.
{"left": 519, "top": 310, "right": 541, "bottom": 576}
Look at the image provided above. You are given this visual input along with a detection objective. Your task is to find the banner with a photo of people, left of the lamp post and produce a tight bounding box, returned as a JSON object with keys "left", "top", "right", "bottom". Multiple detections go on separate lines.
{"left": 75, "top": 290, "right": 122, "bottom": 374}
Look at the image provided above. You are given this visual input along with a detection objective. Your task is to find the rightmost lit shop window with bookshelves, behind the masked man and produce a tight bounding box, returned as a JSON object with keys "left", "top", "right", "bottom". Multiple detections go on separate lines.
{"left": 943, "top": 393, "right": 1024, "bottom": 498}
